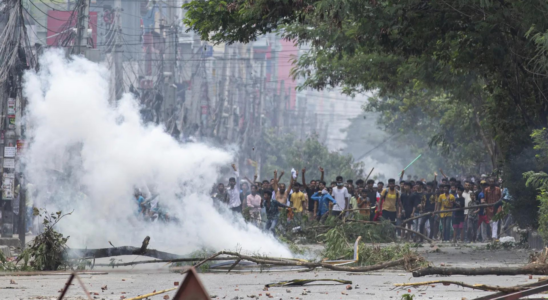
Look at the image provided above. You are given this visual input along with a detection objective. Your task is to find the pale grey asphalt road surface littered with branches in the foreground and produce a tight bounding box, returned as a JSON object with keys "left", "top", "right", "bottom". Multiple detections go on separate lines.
{"left": 0, "top": 245, "right": 538, "bottom": 300}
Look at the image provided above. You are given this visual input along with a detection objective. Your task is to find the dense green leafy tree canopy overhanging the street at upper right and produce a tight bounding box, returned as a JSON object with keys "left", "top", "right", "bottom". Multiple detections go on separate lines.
{"left": 184, "top": 0, "right": 548, "bottom": 223}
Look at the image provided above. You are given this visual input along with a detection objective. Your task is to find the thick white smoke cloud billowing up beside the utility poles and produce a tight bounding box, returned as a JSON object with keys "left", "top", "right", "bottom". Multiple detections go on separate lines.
{"left": 24, "top": 50, "right": 290, "bottom": 256}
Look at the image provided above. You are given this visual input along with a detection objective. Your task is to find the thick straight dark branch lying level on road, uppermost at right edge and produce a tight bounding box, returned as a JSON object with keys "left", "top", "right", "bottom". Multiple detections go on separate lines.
{"left": 413, "top": 264, "right": 548, "bottom": 277}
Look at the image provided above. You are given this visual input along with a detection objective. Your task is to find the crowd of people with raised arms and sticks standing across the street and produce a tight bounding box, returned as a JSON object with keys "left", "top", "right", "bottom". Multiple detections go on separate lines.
{"left": 212, "top": 165, "right": 512, "bottom": 242}
